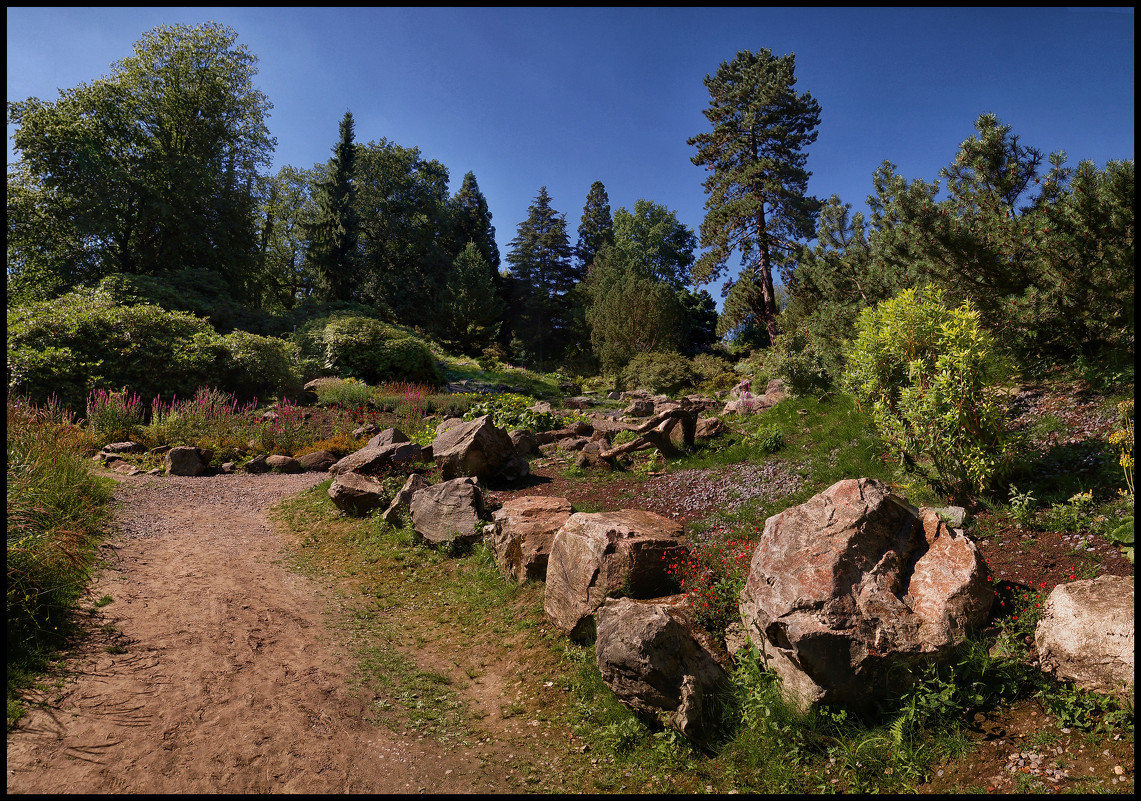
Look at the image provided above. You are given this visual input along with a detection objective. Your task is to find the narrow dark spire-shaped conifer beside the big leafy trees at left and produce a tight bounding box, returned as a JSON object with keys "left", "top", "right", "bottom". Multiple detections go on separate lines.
{"left": 306, "top": 112, "right": 359, "bottom": 300}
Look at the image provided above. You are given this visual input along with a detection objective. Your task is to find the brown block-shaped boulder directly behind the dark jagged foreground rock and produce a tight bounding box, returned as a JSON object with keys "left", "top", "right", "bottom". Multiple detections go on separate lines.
{"left": 543, "top": 509, "right": 688, "bottom": 639}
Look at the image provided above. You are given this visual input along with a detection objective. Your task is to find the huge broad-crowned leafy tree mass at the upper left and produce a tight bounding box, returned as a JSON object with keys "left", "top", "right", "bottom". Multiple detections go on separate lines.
{"left": 8, "top": 23, "right": 274, "bottom": 300}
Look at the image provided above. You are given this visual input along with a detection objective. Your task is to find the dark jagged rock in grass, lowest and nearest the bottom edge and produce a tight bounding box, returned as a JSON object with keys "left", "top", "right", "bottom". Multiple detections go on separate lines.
{"left": 594, "top": 596, "right": 728, "bottom": 744}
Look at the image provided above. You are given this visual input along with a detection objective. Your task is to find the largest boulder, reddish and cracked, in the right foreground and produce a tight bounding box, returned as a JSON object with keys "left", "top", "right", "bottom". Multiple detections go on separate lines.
{"left": 741, "top": 478, "right": 994, "bottom": 707}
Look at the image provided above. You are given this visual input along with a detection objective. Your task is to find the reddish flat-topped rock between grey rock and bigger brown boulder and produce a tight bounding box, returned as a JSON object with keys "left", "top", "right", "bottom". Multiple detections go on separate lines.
{"left": 486, "top": 495, "right": 573, "bottom": 583}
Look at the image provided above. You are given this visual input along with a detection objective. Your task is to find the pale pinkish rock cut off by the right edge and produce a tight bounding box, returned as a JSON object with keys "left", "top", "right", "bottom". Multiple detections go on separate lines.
{"left": 1034, "top": 576, "right": 1135, "bottom": 698}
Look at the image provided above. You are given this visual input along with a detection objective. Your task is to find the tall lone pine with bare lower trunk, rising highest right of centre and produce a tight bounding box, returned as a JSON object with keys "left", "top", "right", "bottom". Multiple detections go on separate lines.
{"left": 688, "top": 48, "right": 820, "bottom": 341}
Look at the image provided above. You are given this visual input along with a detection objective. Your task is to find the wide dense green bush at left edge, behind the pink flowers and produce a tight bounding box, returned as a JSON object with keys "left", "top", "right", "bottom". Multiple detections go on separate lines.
{"left": 8, "top": 290, "right": 225, "bottom": 412}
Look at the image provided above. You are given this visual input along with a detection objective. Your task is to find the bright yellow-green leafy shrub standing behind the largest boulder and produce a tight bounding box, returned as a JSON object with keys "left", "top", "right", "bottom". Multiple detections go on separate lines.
{"left": 843, "top": 289, "right": 1015, "bottom": 495}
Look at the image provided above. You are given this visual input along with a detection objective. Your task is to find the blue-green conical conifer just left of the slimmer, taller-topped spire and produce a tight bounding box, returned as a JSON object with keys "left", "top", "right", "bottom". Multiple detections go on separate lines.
{"left": 507, "top": 186, "right": 576, "bottom": 367}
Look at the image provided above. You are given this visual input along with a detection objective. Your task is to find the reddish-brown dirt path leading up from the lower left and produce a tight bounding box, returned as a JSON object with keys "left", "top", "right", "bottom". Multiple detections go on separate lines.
{"left": 7, "top": 474, "right": 503, "bottom": 793}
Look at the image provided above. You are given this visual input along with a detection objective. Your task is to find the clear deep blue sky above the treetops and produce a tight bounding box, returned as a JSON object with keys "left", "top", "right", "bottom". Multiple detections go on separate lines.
{"left": 7, "top": 7, "right": 1134, "bottom": 297}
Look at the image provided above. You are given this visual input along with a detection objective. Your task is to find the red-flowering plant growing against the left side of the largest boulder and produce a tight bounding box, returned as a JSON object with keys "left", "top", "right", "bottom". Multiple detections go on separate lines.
{"left": 667, "top": 526, "right": 756, "bottom": 633}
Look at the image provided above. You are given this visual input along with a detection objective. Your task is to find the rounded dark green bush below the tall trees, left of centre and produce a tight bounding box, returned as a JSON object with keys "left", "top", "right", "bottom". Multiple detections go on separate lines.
{"left": 307, "top": 315, "right": 443, "bottom": 386}
